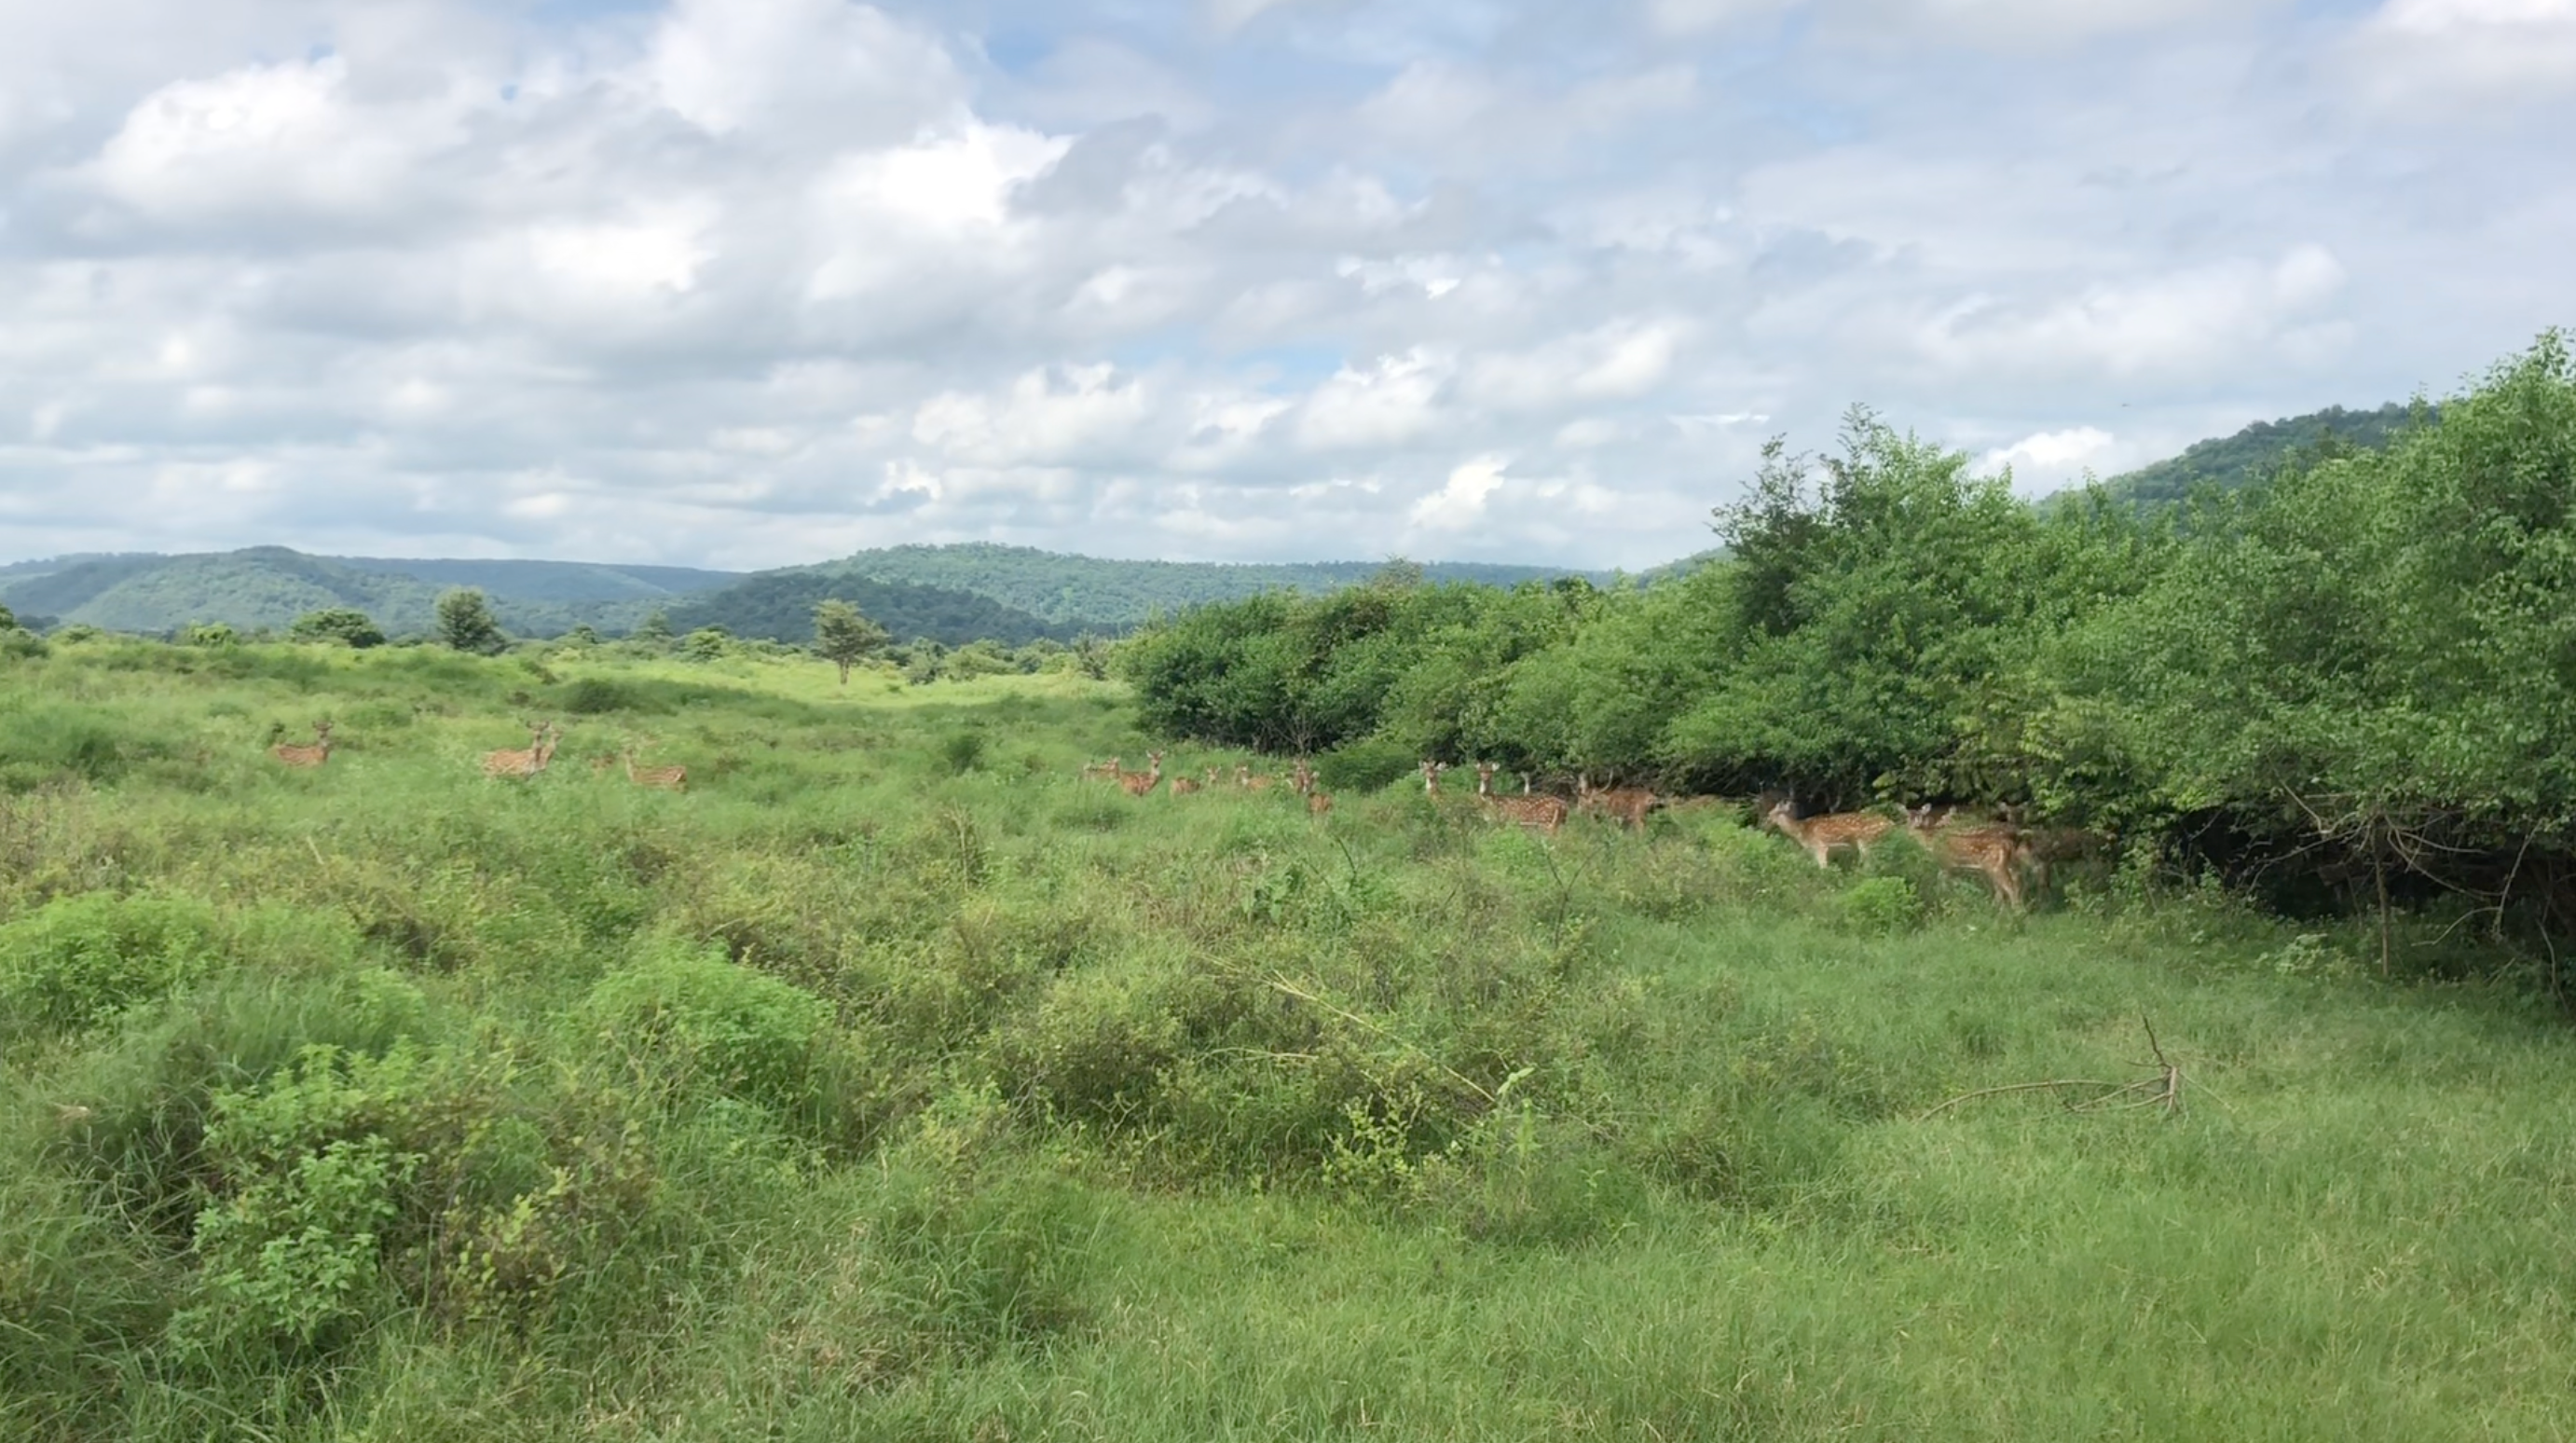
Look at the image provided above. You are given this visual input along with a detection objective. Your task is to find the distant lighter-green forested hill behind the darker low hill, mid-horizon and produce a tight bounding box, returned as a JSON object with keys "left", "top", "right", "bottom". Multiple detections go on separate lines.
{"left": 803, "top": 543, "right": 1599, "bottom": 628}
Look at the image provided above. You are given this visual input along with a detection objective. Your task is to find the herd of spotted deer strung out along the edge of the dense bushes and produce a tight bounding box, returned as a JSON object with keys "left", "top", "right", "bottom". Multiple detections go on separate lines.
{"left": 1082, "top": 752, "right": 2102, "bottom": 910}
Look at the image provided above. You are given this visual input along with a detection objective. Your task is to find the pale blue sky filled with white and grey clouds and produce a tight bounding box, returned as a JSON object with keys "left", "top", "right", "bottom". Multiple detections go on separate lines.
{"left": 0, "top": 0, "right": 2576, "bottom": 570}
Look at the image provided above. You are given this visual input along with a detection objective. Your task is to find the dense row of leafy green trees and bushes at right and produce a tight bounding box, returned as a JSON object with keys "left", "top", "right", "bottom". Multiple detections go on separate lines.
{"left": 1123, "top": 333, "right": 2576, "bottom": 933}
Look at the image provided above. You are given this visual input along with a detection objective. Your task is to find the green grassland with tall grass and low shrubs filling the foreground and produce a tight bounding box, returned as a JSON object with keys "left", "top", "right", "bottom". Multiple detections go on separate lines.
{"left": 0, "top": 641, "right": 2576, "bottom": 1440}
